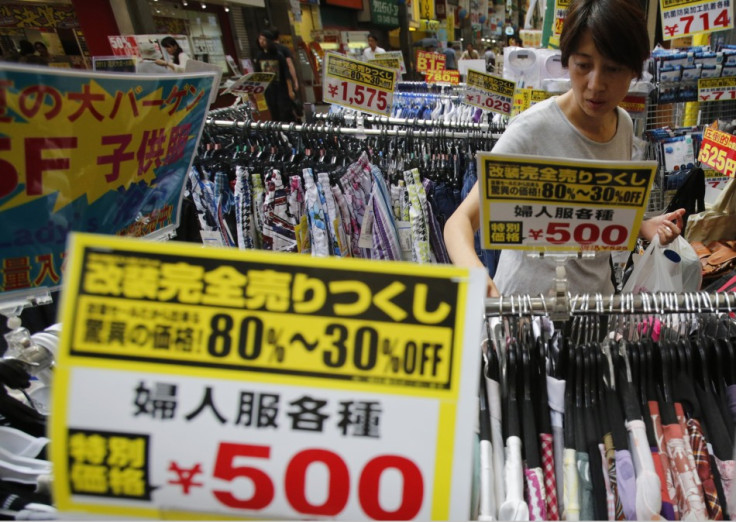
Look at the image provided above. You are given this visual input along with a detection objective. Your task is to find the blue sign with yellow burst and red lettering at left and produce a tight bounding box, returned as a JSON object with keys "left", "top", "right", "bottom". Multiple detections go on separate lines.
{"left": 0, "top": 64, "right": 213, "bottom": 300}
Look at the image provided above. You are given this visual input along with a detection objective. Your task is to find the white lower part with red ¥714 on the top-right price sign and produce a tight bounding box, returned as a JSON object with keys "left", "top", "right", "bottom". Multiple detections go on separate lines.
{"left": 662, "top": 2, "right": 733, "bottom": 40}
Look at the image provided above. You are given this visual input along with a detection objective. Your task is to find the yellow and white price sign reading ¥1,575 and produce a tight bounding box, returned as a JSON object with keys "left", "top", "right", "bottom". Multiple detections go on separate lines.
{"left": 322, "top": 53, "right": 398, "bottom": 116}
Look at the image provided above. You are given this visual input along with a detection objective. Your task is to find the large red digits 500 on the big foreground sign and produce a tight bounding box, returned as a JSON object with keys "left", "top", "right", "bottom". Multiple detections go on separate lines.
{"left": 212, "top": 442, "right": 424, "bottom": 520}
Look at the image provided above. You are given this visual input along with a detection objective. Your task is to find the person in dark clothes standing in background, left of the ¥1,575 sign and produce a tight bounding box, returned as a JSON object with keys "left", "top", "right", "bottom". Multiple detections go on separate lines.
{"left": 253, "top": 29, "right": 296, "bottom": 122}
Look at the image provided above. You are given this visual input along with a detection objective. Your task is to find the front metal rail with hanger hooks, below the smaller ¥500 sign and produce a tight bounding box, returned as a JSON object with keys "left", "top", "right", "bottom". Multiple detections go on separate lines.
{"left": 485, "top": 292, "right": 736, "bottom": 320}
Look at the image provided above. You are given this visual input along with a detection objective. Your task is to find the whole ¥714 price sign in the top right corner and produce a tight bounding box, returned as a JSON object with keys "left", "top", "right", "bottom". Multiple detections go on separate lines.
{"left": 659, "top": 0, "right": 733, "bottom": 40}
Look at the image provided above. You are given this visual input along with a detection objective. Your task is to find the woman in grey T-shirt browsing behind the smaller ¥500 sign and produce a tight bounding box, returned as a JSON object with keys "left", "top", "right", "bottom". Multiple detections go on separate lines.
{"left": 445, "top": 0, "right": 685, "bottom": 296}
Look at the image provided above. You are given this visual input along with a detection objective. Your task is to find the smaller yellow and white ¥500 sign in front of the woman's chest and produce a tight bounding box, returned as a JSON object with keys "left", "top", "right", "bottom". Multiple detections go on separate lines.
{"left": 478, "top": 153, "right": 657, "bottom": 251}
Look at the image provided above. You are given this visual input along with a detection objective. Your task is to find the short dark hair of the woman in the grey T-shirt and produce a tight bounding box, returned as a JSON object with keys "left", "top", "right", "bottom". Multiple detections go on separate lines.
{"left": 560, "top": 0, "right": 650, "bottom": 77}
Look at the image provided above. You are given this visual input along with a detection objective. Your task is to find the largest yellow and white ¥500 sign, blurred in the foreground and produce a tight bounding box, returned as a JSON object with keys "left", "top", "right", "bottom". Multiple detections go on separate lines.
{"left": 51, "top": 234, "right": 486, "bottom": 520}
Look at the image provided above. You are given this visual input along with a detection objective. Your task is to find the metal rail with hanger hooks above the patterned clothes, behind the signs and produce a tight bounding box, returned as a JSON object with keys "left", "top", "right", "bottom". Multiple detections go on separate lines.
{"left": 206, "top": 118, "right": 493, "bottom": 139}
